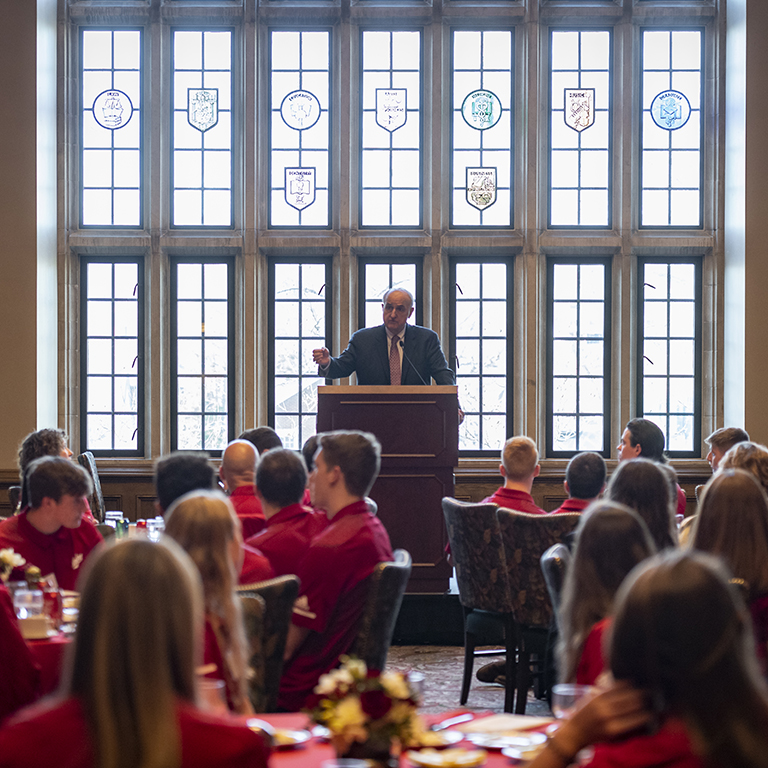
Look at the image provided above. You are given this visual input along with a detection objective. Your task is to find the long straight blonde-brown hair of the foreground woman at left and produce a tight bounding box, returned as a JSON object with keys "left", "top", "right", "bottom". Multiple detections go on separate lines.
{"left": 62, "top": 539, "right": 202, "bottom": 768}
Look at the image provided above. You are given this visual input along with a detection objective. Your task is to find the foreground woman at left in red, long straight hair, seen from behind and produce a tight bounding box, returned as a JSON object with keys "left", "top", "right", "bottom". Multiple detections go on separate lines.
{"left": 0, "top": 539, "right": 269, "bottom": 768}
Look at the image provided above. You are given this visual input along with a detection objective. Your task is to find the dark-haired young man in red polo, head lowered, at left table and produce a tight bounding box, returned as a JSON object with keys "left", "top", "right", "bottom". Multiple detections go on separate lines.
{"left": 0, "top": 456, "right": 102, "bottom": 589}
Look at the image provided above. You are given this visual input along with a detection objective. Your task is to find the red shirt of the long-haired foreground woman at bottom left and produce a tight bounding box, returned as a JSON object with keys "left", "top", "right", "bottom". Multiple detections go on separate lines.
{"left": 0, "top": 698, "right": 269, "bottom": 768}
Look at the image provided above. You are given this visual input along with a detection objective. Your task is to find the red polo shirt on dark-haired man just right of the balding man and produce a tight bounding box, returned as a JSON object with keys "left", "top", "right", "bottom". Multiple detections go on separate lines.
{"left": 246, "top": 504, "right": 328, "bottom": 576}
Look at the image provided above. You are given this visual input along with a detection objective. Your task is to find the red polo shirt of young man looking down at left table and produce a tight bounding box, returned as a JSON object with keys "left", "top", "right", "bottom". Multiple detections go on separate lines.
{"left": 0, "top": 512, "right": 104, "bottom": 589}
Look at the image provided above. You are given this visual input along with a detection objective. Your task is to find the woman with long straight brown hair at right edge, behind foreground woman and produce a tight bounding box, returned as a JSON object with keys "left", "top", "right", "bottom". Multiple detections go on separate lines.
{"left": 691, "top": 468, "right": 768, "bottom": 674}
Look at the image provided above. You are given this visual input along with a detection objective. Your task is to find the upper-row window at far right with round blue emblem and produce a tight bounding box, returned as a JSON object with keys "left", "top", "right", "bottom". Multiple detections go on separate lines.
{"left": 640, "top": 29, "right": 702, "bottom": 227}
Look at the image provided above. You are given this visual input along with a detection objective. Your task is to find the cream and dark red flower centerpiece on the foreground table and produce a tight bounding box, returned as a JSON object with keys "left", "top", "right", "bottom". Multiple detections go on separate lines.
{"left": 306, "top": 656, "right": 424, "bottom": 765}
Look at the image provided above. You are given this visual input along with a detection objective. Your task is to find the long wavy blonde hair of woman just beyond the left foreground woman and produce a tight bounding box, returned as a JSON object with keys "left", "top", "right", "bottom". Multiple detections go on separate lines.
{"left": 165, "top": 491, "right": 250, "bottom": 713}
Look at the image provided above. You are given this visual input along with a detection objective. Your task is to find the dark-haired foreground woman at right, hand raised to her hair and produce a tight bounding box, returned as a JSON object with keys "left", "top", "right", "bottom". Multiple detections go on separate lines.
{"left": 530, "top": 550, "right": 768, "bottom": 768}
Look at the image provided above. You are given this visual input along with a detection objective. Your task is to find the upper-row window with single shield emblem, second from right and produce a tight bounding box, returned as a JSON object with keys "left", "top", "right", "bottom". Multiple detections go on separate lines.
{"left": 549, "top": 30, "right": 611, "bottom": 227}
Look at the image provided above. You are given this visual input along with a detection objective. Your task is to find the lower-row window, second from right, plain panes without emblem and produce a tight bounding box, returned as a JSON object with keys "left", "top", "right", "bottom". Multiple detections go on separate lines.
{"left": 547, "top": 264, "right": 610, "bottom": 454}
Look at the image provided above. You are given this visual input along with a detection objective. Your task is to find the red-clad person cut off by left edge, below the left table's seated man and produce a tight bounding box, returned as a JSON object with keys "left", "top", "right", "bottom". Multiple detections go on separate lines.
{"left": 0, "top": 584, "right": 40, "bottom": 723}
